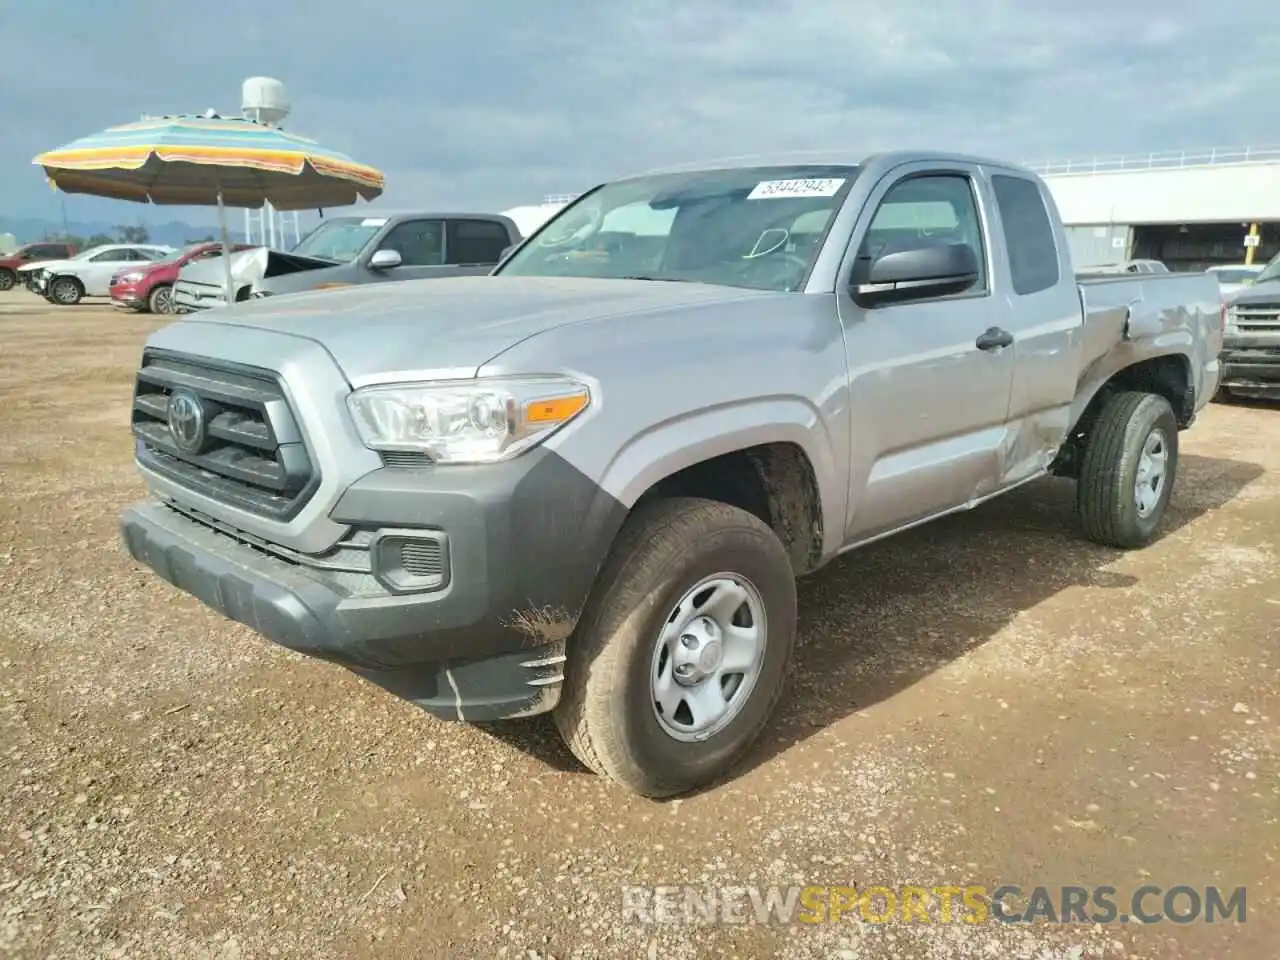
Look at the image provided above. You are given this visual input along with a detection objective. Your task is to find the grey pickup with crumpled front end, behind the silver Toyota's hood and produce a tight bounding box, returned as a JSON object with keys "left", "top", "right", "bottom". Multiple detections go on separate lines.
{"left": 174, "top": 212, "right": 520, "bottom": 312}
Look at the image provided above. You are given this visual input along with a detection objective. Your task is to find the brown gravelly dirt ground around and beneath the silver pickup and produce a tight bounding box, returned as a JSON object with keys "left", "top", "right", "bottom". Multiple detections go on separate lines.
{"left": 0, "top": 291, "right": 1280, "bottom": 960}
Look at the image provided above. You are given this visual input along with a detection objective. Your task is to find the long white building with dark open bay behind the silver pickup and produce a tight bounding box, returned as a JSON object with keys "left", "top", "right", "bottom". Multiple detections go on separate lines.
{"left": 1029, "top": 147, "right": 1280, "bottom": 270}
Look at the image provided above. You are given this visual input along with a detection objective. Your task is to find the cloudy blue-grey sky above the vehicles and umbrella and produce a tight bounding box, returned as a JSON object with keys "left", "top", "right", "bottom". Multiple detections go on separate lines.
{"left": 0, "top": 0, "right": 1280, "bottom": 224}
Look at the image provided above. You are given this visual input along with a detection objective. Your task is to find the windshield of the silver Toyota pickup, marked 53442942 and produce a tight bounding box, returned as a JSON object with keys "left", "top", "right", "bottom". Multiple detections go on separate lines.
{"left": 495, "top": 165, "right": 858, "bottom": 291}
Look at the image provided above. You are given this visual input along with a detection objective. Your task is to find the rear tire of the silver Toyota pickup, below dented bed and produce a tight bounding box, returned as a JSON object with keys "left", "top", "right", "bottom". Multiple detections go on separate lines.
{"left": 1076, "top": 393, "right": 1178, "bottom": 550}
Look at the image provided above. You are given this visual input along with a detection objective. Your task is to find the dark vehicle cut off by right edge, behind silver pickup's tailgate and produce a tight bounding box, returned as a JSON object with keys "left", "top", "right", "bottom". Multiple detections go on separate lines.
{"left": 1219, "top": 255, "right": 1280, "bottom": 399}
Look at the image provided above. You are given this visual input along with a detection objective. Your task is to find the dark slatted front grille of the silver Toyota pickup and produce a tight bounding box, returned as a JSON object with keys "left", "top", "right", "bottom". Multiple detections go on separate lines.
{"left": 132, "top": 352, "right": 319, "bottom": 520}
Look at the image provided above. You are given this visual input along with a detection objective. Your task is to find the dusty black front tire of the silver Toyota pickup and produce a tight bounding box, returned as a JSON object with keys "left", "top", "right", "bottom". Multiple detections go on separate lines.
{"left": 554, "top": 498, "right": 796, "bottom": 797}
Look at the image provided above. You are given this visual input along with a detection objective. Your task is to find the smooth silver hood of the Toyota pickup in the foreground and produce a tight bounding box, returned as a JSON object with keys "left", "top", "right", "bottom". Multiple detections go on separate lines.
{"left": 180, "top": 276, "right": 778, "bottom": 387}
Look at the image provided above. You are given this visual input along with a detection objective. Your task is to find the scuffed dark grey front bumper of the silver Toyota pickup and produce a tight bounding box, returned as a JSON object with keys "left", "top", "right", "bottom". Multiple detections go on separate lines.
{"left": 122, "top": 451, "right": 625, "bottom": 722}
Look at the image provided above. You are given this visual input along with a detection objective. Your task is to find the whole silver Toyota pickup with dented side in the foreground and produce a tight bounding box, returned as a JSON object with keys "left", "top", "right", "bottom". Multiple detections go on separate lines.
{"left": 123, "top": 152, "right": 1224, "bottom": 796}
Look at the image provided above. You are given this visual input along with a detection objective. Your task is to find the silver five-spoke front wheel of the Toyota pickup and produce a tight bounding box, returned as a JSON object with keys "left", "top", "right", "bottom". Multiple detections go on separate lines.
{"left": 649, "top": 573, "right": 768, "bottom": 742}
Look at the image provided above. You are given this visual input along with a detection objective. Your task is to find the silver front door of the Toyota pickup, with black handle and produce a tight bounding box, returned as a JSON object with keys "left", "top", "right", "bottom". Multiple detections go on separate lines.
{"left": 837, "top": 164, "right": 1014, "bottom": 543}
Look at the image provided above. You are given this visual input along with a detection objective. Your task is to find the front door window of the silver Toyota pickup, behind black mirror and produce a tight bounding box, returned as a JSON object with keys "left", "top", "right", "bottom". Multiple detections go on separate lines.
{"left": 858, "top": 174, "right": 988, "bottom": 296}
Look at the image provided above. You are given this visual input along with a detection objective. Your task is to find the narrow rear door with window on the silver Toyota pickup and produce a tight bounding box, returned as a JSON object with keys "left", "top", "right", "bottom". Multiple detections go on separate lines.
{"left": 989, "top": 169, "right": 1084, "bottom": 485}
